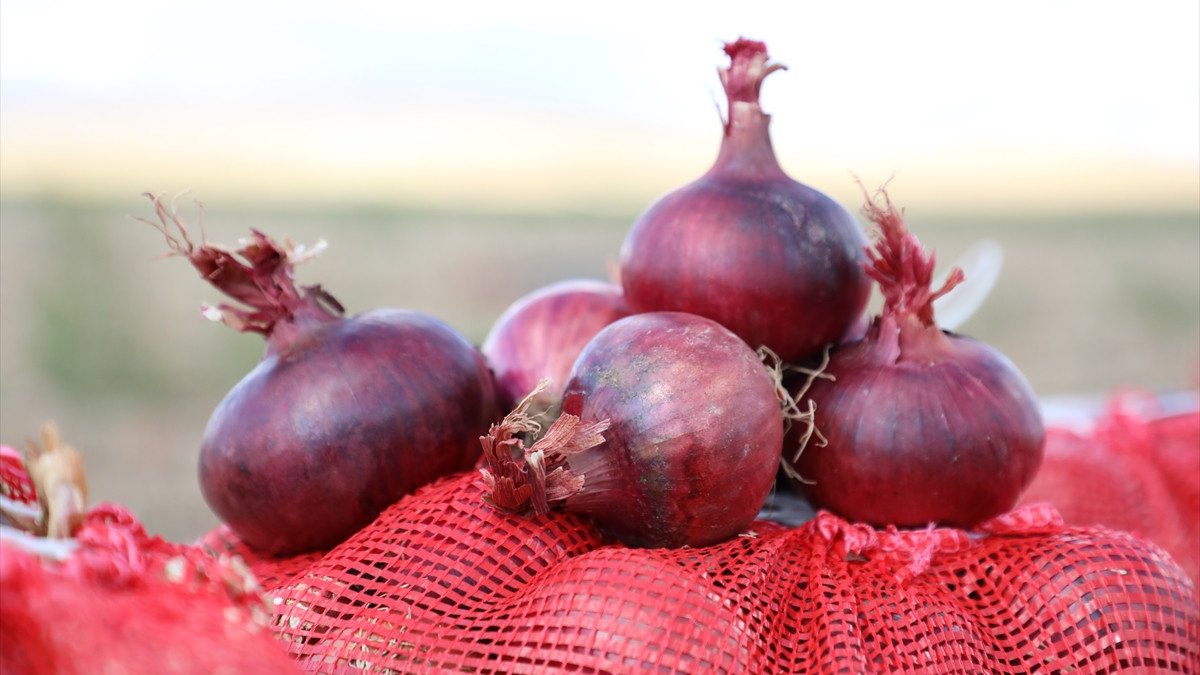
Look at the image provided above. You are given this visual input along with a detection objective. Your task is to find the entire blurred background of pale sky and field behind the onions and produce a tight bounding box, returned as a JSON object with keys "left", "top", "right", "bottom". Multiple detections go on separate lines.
{"left": 0, "top": 0, "right": 1200, "bottom": 539}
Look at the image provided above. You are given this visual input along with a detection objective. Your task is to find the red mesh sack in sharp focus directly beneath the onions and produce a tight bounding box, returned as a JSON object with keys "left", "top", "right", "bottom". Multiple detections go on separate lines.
{"left": 202, "top": 474, "right": 1200, "bottom": 673}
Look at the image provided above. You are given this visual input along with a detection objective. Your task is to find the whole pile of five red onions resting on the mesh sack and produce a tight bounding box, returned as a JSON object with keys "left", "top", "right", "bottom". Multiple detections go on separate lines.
{"left": 129, "top": 40, "right": 1043, "bottom": 555}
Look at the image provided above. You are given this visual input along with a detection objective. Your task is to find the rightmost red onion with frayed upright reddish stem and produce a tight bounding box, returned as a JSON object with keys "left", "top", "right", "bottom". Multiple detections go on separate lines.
{"left": 784, "top": 187, "right": 1044, "bottom": 527}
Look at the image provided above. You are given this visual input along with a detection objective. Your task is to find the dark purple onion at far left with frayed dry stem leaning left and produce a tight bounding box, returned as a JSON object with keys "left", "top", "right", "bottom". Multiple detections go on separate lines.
{"left": 142, "top": 196, "right": 497, "bottom": 555}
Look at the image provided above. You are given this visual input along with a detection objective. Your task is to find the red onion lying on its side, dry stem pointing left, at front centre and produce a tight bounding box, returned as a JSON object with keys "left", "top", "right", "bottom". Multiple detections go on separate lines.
{"left": 482, "top": 312, "right": 784, "bottom": 548}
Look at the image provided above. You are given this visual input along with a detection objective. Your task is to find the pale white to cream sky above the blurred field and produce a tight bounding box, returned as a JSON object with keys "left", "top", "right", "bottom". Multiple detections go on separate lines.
{"left": 0, "top": 0, "right": 1200, "bottom": 209}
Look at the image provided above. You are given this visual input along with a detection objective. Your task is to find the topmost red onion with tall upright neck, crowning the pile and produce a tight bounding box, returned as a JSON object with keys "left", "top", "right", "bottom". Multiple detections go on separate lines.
{"left": 620, "top": 40, "right": 870, "bottom": 362}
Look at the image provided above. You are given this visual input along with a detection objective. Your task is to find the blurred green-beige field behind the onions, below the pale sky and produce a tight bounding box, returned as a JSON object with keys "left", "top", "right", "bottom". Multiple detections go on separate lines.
{"left": 0, "top": 199, "right": 1200, "bottom": 539}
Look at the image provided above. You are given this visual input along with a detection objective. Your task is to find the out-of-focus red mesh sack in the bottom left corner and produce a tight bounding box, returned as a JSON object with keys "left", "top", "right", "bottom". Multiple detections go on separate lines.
{"left": 0, "top": 447, "right": 298, "bottom": 675}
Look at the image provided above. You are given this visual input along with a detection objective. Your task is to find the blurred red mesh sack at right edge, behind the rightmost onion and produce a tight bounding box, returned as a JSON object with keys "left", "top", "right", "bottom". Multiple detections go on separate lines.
{"left": 1022, "top": 392, "right": 1200, "bottom": 583}
